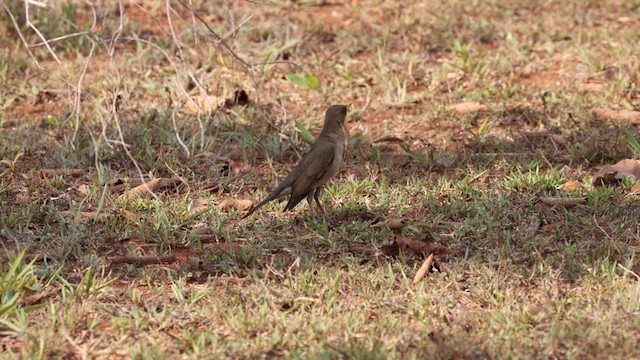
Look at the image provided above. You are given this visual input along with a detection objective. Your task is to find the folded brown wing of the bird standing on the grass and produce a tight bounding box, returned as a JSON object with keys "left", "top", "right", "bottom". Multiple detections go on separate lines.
{"left": 284, "top": 142, "right": 336, "bottom": 211}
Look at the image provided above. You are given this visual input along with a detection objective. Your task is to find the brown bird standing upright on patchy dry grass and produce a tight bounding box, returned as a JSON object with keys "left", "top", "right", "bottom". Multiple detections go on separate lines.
{"left": 242, "top": 105, "right": 349, "bottom": 219}
